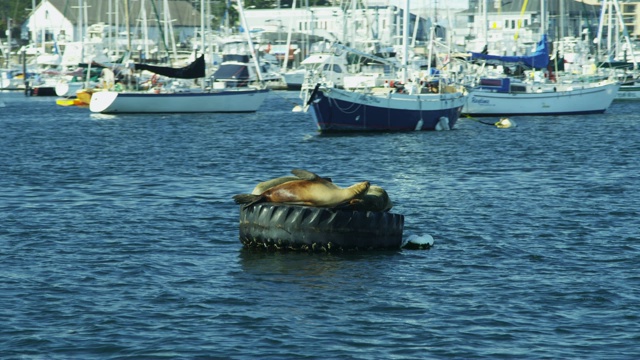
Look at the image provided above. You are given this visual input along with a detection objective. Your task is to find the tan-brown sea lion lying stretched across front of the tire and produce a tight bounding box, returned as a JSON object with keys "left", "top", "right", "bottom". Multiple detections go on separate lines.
{"left": 233, "top": 169, "right": 370, "bottom": 208}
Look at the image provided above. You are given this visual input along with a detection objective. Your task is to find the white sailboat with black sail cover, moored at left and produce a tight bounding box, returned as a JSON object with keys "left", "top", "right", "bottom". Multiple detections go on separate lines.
{"left": 89, "top": 54, "right": 269, "bottom": 114}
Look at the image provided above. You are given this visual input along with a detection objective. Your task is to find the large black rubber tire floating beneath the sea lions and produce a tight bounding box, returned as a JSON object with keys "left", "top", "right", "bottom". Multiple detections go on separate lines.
{"left": 240, "top": 203, "right": 404, "bottom": 252}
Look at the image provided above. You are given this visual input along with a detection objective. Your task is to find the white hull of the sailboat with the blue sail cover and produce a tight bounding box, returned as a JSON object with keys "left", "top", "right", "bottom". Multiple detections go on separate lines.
{"left": 462, "top": 81, "right": 620, "bottom": 116}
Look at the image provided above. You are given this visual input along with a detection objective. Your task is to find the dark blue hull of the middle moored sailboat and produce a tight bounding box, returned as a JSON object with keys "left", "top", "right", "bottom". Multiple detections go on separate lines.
{"left": 308, "top": 88, "right": 464, "bottom": 132}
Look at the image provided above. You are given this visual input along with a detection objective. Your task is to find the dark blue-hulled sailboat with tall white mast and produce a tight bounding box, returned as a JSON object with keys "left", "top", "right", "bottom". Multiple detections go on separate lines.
{"left": 303, "top": 0, "right": 466, "bottom": 133}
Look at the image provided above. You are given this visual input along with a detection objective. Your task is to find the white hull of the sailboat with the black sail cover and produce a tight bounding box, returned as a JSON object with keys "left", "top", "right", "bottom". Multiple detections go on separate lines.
{"left": 89, "top": 89, "right": 269, "bottom": 114}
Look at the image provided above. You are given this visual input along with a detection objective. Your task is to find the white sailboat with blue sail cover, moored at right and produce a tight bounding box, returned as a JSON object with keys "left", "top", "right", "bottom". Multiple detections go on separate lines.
{"left": 462, "top": 1, "right": 620, "bottom": 116}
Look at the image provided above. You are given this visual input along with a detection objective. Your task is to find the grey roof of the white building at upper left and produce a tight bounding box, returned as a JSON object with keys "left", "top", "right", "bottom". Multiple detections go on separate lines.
{"left": 41, "top": 0, "right": 200, "bottom": 26}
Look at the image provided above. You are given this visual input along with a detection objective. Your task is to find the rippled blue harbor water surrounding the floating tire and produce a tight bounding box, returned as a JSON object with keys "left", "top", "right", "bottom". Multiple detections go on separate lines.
{"left": 0, "top": 92, "right": 640, "bottom": 359}
